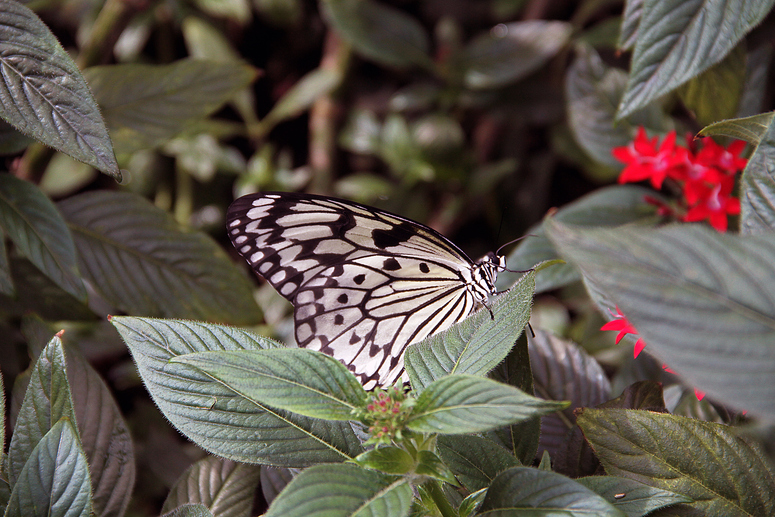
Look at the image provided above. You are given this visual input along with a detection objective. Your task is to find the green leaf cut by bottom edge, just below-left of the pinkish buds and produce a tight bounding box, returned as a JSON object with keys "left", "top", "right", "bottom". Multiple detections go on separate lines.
{"left": 265, "top": 464, "right": 412, "bottom": 517}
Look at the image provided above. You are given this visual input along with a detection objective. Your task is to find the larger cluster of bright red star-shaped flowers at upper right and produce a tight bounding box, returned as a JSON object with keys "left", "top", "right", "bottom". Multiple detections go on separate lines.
{"left": 612, "top": 127, "right": 748, "bottom": 232}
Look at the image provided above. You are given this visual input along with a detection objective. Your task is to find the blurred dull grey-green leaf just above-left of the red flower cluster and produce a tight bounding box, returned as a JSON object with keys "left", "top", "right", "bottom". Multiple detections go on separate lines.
{"left": 565, "top": 45, "right": 670, "bottom": 170}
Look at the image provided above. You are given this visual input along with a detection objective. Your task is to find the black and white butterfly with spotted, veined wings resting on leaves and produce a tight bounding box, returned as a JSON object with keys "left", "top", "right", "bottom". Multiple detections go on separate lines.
{"left": 227, "top": 192, "right": 506, "bottom": 389}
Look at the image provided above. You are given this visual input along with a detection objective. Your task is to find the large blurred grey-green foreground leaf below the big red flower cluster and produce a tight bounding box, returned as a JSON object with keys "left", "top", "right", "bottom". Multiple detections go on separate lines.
{"left": 547, "top": 221, "right": 775, "bottom": 416}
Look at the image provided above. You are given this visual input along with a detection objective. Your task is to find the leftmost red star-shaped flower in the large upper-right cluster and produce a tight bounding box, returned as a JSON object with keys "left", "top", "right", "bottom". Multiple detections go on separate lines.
{"left": 611, "top": 127, "right": 682, "bottom": 189}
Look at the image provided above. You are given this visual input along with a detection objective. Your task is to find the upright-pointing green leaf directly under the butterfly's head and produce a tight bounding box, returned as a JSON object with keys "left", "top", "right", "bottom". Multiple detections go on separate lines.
{"left": 404, "top": 271, "right": 535, "bottom": 392}
